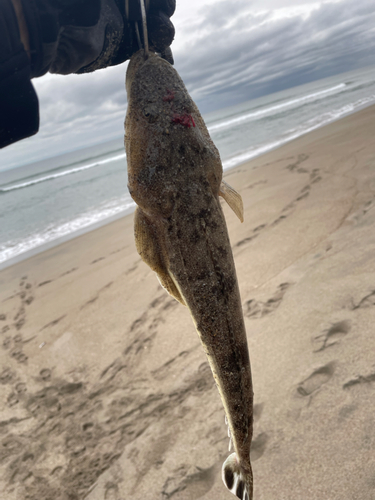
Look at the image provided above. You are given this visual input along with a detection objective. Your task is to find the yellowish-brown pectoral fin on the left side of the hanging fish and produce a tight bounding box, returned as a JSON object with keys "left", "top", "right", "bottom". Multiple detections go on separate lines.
{"left": 134, "top": 207, "right": 185, "bottom": 305}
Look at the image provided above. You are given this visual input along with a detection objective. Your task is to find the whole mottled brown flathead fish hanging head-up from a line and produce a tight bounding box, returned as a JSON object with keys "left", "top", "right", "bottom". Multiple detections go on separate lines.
{"left": 125, "top": 50, "right": 253, "bottom": 500}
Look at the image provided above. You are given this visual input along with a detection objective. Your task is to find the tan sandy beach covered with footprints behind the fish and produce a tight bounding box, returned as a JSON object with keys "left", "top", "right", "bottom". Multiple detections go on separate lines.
{"left": 0, "top": 103, "right": 375, "bottom": 500}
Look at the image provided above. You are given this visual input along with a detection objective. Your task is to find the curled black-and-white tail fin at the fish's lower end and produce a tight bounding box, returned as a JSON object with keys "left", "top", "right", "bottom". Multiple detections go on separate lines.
{"left": 222, "top": 453, "right": 253, "bottom": 500}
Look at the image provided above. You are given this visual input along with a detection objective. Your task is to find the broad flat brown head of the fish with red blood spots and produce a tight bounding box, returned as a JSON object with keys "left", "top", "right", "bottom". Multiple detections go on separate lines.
{"left": 125, "top": 50, "right": 222, "bottom": 218}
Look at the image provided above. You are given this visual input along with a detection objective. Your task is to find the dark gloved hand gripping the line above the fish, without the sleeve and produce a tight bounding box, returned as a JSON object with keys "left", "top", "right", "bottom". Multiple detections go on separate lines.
{"left": 22, "top": 0, "right": 175, "bottom": 77}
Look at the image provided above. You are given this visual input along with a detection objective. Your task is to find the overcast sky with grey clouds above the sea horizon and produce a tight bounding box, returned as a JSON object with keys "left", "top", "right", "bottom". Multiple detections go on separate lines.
{"left": 0, "top": 0, "right": 375, "bottom": 170}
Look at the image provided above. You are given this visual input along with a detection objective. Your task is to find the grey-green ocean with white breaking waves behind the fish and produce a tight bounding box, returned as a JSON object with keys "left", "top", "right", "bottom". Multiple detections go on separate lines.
{"left": 0, "top": 68, "right": 375, "bottom": 269}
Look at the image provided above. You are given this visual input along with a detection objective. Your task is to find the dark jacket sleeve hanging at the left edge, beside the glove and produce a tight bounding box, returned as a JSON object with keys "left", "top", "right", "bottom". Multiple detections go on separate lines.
{"left": 0, "top": 0, "right": 39, "bottom": 148}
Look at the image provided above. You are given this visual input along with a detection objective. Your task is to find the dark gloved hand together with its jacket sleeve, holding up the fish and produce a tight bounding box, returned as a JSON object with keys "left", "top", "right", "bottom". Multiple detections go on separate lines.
{"left": 0, "top": 0, "right": 175, "bottom": 148}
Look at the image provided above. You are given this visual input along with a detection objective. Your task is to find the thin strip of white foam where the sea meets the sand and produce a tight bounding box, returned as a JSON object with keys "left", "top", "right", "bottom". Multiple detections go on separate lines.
{"left": 0, "top": 104, "right": 375, "bottom": 271}
